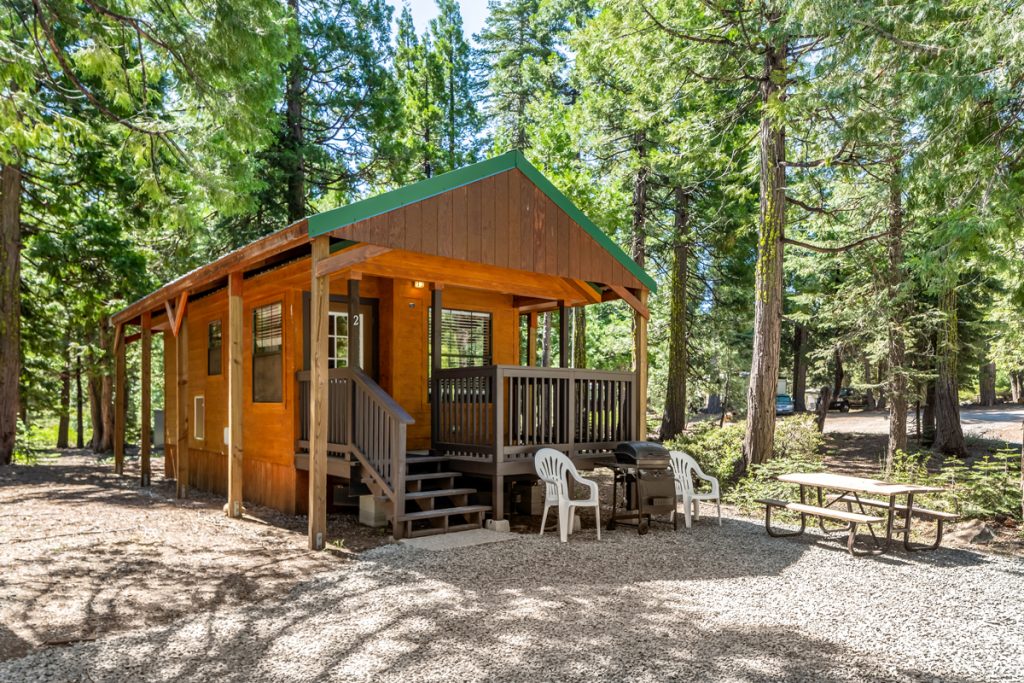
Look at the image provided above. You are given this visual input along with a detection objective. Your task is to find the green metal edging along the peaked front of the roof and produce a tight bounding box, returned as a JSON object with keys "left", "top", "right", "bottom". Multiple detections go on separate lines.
{"left": 308, "top": 150, "right": 657, "bottom": 292}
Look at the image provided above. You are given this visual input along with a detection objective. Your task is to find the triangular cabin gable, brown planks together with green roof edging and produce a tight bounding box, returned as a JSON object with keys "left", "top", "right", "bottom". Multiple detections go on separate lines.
{"left": 308, "top": 151, "right": 657, "bottom": 291}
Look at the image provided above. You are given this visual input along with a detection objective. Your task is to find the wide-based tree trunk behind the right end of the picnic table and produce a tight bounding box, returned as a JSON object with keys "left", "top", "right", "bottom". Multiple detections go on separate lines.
{"left": 932, "top": 283, "right": 967, "bottom": 456}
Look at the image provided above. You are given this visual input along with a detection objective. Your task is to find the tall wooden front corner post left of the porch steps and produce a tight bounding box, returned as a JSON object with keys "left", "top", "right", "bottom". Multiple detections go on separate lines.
{"left": 309, "top": 234, "right": 327, "bottom": 550}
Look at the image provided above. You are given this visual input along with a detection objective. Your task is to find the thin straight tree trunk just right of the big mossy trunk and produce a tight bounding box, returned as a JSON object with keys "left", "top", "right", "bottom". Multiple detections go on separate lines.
{"left": 880, "top": 161, "right": 909, "bottom": 474}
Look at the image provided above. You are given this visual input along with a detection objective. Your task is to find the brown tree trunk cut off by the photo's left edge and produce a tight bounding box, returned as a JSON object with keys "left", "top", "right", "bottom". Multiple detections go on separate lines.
{"left": 0, "top": 164, "right": 22, "bottom": 465}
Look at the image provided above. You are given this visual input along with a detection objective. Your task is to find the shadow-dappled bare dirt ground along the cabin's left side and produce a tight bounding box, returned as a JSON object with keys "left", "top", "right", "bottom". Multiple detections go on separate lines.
{"left": 0, "top": 451, "right": 387, "bottom": 660}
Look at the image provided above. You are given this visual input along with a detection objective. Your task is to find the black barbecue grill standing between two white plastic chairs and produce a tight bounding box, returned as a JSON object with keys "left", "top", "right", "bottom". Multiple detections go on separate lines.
{"left": 595, "top": 441, "right": 677, "bottom": 535}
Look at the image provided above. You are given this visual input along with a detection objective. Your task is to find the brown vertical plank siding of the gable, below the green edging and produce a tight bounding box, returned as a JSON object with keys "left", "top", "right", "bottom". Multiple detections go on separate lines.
{"left": 332, "top": 169, "right": 641, "bottom": 289}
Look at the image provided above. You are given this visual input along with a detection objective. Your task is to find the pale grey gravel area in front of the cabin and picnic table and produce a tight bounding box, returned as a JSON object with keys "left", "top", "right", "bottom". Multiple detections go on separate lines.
{"left": 0, "top": 518, "right": 1024, "bottom": 682}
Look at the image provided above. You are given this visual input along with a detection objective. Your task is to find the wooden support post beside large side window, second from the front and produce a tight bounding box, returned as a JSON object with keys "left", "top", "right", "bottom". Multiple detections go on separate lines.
{"left": 227, "top": 270, "right": 243, "bottom": 518}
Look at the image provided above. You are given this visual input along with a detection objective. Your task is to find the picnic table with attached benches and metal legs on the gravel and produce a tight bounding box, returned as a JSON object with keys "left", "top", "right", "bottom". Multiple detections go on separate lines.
{"left": 758, "top": 472, "right": 956, "bottom": 555}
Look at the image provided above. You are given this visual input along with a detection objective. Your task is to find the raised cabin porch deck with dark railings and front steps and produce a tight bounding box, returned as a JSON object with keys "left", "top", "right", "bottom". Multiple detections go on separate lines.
{"left": 296, "top": 366, "right": 637, "bottom": 536}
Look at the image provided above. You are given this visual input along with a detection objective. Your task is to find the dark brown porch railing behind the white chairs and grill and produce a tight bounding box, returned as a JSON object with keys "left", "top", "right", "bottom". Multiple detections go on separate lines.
{"left": 431, "top": 366, "right": 637, "bottom": 463}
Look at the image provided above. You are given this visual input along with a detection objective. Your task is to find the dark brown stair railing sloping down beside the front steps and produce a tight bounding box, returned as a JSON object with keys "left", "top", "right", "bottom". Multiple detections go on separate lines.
{"left": 296, "top": 368, "right": 415, "bottom": 501}
